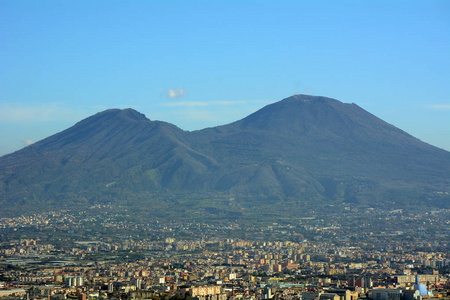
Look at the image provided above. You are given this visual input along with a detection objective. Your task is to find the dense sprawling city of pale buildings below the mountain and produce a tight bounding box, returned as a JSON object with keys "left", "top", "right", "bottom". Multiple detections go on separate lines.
{"left": 0, "top": 205, "right": 450, "bottom": 300}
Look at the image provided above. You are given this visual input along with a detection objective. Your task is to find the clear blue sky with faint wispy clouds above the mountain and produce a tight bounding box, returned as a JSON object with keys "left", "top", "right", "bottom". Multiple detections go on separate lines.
{"left": 0, "top": 0, "right": 450, "bottom": 155}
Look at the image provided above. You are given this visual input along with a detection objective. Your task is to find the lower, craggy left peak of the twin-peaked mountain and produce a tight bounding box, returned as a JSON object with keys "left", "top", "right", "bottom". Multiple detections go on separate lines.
{"left": 0, "top": 109, "right": 216, "bottom": 207}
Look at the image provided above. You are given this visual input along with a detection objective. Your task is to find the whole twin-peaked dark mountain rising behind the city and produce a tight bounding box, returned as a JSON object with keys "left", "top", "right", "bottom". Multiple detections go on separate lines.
{"left": 0, "top": 95, "right": 450, "bottom": 213}
